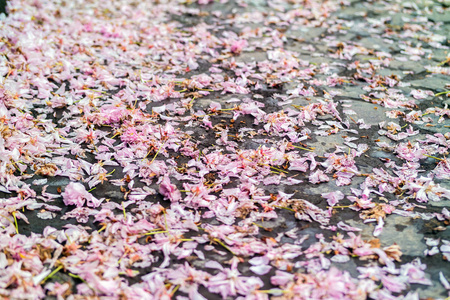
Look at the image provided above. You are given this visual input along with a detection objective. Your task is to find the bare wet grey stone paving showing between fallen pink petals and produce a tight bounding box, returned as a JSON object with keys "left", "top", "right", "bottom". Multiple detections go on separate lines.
{"left": 0, "top": 1, "right": 450, "bottom": 299}
